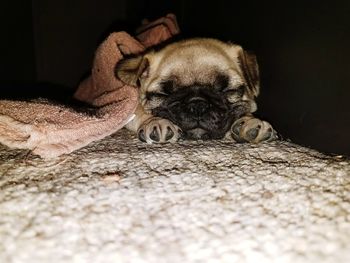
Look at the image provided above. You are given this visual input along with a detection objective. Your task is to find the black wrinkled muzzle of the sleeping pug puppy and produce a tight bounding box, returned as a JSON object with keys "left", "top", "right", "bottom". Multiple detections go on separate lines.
{"left": 152, "top": 86, "right": 241, "bottom": 140}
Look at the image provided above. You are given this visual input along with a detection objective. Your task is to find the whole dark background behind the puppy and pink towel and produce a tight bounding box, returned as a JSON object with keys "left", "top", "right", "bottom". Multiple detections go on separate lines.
{"left": 0, "top": 0, "right": 350, "bottom": 155}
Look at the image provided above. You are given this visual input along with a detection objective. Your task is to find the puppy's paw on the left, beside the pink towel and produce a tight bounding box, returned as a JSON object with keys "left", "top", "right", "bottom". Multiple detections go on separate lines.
{"left": 137, "top": 117, "right": 181, "bottom": 143}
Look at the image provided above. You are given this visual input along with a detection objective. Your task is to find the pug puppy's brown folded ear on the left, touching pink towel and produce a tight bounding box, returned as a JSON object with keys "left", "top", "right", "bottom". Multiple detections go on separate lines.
{"left": 115, "top": 56, "right": 149, "bottom": 87}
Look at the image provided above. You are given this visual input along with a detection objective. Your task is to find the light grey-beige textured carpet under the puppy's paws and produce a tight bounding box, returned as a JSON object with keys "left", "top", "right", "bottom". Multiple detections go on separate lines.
{"left": 0, "top": 130, "right": 350, "bottom": 263}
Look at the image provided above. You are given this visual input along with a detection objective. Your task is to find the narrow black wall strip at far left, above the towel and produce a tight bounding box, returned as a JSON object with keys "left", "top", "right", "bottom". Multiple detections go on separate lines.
{"left": 0, "top": 0, "right": 36, "bottom": 85}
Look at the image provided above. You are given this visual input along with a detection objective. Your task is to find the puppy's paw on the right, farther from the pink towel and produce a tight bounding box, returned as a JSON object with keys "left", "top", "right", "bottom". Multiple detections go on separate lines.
{"left": 231, "top": 116, "right": 278, "bottom": 143}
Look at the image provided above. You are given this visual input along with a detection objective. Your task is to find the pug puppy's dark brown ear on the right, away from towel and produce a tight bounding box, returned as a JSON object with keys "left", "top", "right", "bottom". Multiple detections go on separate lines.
{"left": 238, "top": 49, "right": 260, "bottom": 97}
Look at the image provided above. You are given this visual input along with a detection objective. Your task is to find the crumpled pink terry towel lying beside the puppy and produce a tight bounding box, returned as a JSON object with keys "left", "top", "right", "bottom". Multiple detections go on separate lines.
{"left": 0, "top": 15, "right": 179, "bottom": 158}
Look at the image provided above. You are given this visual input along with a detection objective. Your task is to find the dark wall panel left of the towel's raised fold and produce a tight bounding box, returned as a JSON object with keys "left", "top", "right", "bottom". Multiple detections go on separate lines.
{"left": 33, "top": 0, "right": 125, "bottom": 87}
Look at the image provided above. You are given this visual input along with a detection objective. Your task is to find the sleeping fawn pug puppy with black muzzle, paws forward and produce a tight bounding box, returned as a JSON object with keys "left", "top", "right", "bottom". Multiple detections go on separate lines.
{"left": 115, "top": 38, "right": 277, "bottom": 143}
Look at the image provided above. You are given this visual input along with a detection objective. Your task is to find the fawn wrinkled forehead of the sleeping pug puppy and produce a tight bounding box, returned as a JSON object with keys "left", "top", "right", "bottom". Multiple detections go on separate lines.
{"left": 150, "top": 46, "right": 241, "bottom": 86}
